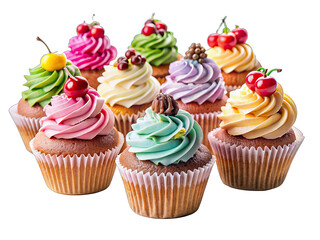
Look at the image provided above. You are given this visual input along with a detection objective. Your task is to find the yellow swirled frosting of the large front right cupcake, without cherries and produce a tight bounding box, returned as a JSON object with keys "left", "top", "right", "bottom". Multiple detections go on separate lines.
{"left": 218, "top": 83, "right": 297, "bottom": 139}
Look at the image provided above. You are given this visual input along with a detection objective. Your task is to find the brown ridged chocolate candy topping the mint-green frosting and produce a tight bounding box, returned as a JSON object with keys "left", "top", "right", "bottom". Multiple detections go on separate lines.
{"left": 151, "top": 93, "right": 179, "bottom": 116}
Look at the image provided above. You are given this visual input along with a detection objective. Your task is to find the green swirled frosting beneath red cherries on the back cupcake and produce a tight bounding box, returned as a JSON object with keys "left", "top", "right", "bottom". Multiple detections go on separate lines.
{"left": 130, "top": 32, "right": 178, "bottom": 66}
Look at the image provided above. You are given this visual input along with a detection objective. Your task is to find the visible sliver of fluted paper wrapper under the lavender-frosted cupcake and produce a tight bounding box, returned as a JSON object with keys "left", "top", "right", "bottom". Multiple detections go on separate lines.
{"left": 192, "top": 111, "right": 221, "bottom": 153}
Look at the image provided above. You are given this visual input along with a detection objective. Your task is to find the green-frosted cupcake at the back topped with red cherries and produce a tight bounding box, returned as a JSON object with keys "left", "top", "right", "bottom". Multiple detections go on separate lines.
{"left": 130, "top": 14, "right": 182, "bottom": 84}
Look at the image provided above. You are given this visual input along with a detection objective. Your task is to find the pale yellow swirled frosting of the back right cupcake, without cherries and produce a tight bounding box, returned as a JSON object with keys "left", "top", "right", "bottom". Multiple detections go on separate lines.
{"left": 207, "top": 43, "right": 258, "bottom": 73}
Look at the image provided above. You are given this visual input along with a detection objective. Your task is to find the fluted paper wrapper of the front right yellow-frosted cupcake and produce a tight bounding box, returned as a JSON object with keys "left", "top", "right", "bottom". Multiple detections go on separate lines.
{"left": 209, "top": 128, "right": 304, "bottom": 190}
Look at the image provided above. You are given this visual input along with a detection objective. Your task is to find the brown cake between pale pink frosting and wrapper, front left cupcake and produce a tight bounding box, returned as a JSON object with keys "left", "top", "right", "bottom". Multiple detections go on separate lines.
{"left": 33, "top": 128, "right": 119, "bottom": 156}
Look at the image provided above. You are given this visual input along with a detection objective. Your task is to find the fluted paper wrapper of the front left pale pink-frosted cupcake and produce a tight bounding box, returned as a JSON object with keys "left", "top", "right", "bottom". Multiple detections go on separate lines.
{"left": 30, "top": 133, "right": 124, "bottom": 195}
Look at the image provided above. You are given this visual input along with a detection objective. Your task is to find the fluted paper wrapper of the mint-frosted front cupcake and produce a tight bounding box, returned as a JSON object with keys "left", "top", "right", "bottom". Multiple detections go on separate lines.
{"left": 116, "top": 158, "right": 215, "bottom": 218}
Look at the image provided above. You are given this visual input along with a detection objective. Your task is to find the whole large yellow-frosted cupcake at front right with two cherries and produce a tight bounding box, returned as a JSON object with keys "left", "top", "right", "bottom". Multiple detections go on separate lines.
{"left": 209, "top": 69, "right": 304, "bottom": 190}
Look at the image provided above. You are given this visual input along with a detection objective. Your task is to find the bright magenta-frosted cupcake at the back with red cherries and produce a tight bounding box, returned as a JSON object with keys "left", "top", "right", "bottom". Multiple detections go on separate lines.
{"left": 65, "top": 17, "right": 117, "bottom": 89}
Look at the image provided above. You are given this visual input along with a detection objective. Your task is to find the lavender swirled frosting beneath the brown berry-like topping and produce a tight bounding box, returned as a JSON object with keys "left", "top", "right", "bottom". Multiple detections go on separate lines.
{"left": 161, "top": 58, "right": 225, "bottom": 105}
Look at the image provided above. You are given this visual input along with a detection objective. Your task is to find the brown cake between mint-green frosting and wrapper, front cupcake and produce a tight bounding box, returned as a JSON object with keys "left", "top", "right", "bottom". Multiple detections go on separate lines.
{"left": 119, "top": 145, "right": 212, "bottom": 175}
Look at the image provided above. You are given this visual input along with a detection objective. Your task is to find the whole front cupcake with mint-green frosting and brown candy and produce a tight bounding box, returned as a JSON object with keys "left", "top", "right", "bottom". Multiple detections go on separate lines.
{"left": 116, "top": 94, "right": 214, "bottom": 218}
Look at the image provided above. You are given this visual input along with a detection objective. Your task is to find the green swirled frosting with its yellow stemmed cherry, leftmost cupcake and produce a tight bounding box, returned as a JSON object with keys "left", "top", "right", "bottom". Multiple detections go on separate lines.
{"left": 22, "top": 37, "right": 80, "bottom": 107}
